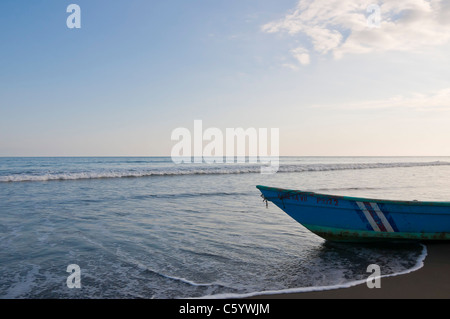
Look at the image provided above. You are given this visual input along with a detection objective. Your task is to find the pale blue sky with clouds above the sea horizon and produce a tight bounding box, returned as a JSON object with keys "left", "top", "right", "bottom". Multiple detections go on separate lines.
{"left": 0, "top": 0, "right": 450, "bottom": 156}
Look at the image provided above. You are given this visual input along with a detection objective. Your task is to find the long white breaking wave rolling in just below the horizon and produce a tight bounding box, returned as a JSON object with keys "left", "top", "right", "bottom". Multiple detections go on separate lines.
{"left": 0, "top": 161, "right": 450, "bottom": 183}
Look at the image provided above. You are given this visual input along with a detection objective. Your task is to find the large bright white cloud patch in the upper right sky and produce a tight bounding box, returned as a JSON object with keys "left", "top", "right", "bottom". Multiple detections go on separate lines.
{"left": 262, "top": 0, "right": 450, "bottom": 64}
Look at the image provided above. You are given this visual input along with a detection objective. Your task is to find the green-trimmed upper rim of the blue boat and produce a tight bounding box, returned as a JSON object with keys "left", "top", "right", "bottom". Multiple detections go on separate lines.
{"left": 256, "top": 185, "right": 450, "bottom": 207}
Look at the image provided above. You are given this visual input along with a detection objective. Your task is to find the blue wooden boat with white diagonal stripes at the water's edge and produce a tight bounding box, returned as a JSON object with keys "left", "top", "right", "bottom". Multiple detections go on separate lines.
{"left": 256, "top": 185, "right": 450, "bottom": 242}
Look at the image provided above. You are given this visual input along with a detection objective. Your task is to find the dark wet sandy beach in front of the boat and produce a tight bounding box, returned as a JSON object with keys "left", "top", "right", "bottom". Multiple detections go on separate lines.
{"left": 256, "top": 242, "right": 450, "bottom": 299}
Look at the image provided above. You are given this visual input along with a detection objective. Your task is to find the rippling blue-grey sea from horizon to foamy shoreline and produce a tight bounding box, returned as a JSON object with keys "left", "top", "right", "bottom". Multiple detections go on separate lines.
{"left": 0, "top": 157, "right": 450, "bottom": 299}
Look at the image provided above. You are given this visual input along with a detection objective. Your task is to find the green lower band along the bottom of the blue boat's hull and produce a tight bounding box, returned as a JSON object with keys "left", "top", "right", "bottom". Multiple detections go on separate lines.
{"left": 303, "top": 225, "right": 450, "bottom": 242}
